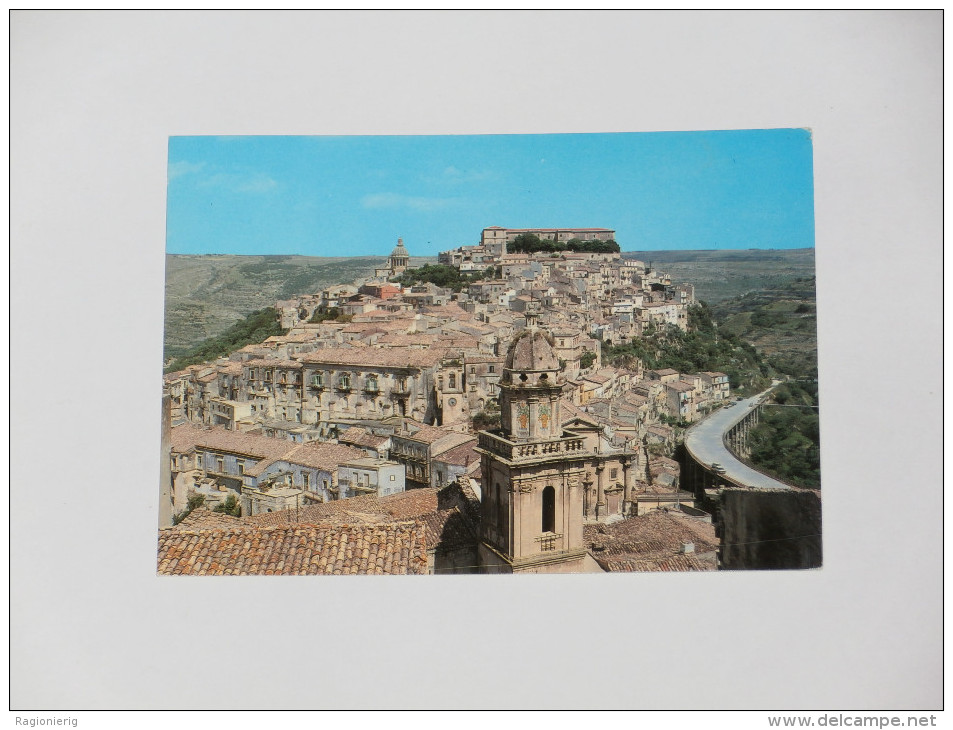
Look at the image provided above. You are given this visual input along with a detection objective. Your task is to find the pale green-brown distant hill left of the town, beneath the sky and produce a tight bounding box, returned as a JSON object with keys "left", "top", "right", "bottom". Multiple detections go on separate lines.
{"left": 165, "top": 254, "right": 436, "bottom": 359}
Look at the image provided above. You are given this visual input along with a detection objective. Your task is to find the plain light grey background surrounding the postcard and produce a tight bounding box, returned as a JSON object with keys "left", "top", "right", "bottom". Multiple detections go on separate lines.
{"left": 10, "top": 11, "right": 942, "bottom": 710}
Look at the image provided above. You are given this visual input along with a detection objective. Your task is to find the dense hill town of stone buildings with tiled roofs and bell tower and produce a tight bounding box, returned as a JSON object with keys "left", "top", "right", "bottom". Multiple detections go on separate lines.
{"left": 159, "top": 226, "right": 812, "bottom": 574}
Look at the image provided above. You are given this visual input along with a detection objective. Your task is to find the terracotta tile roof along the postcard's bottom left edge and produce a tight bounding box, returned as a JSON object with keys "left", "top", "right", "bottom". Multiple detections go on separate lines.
{"left": 158, "top": 522, "right": 427, "bottom": 575}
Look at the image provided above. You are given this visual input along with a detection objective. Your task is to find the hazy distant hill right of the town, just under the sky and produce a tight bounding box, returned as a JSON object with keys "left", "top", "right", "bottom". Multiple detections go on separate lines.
{"left": 622, "top": 248, "right": 814, "bottom": 304}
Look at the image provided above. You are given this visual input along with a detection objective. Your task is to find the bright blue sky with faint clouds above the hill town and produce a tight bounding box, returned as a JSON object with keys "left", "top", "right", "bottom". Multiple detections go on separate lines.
{"left": 167, "top": 129, "right": 814, "bottom": 256}
